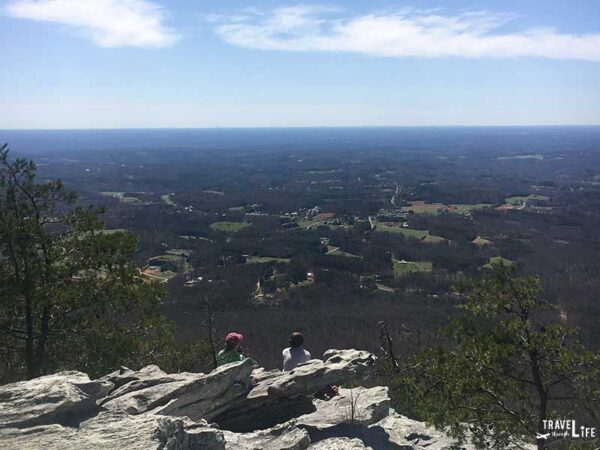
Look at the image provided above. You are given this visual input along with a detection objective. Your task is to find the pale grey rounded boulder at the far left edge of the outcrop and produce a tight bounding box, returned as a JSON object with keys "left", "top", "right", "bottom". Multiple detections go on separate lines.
{"left": 0, "top": 371, "right": 113, "bottom": 428}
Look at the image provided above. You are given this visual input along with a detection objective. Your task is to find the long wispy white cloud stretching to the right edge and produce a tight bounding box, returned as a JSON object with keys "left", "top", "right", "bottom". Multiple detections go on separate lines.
{"left": 215, "top": 5, "right": 600, "bottom": 61}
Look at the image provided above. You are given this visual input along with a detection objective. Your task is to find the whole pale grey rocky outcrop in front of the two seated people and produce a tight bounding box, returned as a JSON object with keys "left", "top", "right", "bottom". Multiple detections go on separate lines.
{"left": 0, "top": 350, "right": 476, "bottom": 450}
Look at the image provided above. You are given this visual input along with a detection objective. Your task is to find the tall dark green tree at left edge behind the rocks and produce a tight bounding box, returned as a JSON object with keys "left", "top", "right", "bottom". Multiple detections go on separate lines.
{"left": 0, "top": 145, "right": 171, "bottom": 380}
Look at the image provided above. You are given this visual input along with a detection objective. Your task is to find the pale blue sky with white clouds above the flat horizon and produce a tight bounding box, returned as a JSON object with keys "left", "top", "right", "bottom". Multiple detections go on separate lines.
{"left": 0, "top": 0, "right": 600, "bottom": 129}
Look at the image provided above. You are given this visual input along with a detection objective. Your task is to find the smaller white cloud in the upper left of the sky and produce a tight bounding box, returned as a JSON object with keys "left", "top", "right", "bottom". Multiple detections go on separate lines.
{"left": 5, "top": 0, "right": 178, "bottom": 48}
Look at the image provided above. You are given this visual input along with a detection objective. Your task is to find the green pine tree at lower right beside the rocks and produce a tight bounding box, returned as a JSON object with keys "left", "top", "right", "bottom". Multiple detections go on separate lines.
{"left": 398, "top": 264, "right": 600, "bottom": 449}
